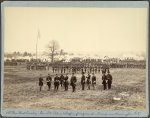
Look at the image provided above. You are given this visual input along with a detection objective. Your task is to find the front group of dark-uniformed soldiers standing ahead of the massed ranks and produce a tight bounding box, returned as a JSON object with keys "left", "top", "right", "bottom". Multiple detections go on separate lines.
{"left": 39, "top": 69, "right": 112, "bottom": 92}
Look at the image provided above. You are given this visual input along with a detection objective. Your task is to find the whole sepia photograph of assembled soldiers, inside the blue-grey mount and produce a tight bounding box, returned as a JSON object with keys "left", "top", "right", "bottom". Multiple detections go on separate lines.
{"left": 1, "top": 2, "right": 148, "bottom": 117}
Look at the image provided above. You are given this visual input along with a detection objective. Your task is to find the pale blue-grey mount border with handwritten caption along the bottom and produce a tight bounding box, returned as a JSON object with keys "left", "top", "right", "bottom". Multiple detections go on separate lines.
{"left": 1, "top": 1, "right": 149, "bottom": 117}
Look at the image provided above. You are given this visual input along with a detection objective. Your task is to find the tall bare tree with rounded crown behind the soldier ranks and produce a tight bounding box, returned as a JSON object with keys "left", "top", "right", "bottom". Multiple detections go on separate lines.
{"left": 47, "top": 40, "right": 59, "bottom": 63}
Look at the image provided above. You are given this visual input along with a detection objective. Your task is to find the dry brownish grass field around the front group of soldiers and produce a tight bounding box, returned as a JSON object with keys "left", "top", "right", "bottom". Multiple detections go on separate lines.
{"left": 3, "top": 66, "right": 146, "bottom": 111}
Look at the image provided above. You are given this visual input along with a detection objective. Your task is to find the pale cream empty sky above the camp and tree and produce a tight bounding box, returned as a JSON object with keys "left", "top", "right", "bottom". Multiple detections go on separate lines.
{"left": 4, "top": 7, "right": 148, "bottom": 53}
